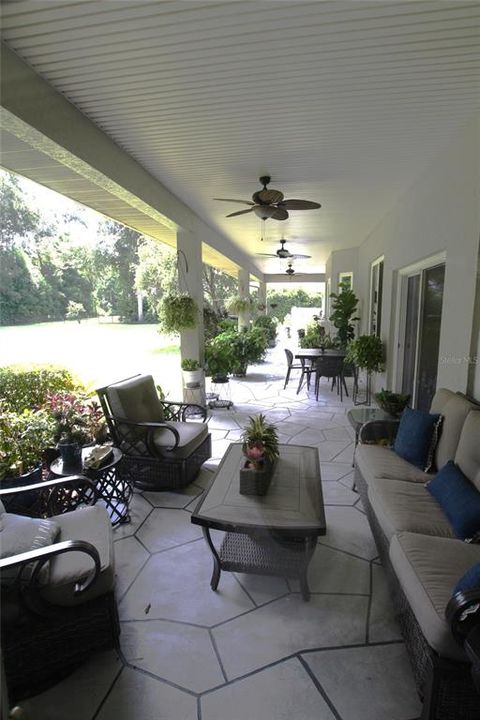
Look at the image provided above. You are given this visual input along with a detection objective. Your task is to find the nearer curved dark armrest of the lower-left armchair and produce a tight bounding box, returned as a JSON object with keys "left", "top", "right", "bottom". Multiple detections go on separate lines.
{"left": 0, "top": 540, "right": 101, "bottom": 595}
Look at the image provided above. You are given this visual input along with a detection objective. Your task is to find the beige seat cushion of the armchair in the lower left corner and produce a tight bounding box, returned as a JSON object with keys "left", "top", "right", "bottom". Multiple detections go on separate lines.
{"left": 42, "top": 504, "right": 115, "bottom": 606}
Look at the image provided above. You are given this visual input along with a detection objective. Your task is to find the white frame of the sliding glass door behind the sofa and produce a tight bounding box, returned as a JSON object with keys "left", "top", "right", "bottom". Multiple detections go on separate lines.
{"left": 391, "top": 251, "right": 447, "bottom": 400}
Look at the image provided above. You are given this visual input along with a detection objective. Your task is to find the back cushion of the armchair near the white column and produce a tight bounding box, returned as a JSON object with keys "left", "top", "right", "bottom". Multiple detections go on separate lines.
{"left": 106, "top": 375, "right": 164, "bottom": 422}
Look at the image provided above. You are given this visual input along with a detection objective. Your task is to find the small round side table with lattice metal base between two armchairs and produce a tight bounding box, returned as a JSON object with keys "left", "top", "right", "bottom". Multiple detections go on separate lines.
{"left": 50, "top": 447, "right": 133, "bottom": 527}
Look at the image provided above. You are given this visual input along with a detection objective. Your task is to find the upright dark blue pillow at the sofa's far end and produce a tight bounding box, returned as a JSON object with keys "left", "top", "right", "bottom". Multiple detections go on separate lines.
{"left": 393, "top": 407, "right": 442, "bottom": 472}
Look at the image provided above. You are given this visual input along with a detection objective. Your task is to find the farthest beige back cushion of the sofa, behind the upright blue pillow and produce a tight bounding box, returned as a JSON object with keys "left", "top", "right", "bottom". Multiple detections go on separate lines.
{"left": 430, "top": 388, "right": 478, "bottom": 474}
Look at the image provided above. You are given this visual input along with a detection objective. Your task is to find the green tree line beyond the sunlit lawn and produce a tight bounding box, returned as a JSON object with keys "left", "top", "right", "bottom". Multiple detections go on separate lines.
{"left": 0, "top": 173, "right": 321, "bottom": 325}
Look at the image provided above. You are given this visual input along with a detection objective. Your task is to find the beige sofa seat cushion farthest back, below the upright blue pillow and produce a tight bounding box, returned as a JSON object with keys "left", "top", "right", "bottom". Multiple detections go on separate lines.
{"left": 355, "top": 445, "right": 432, "bottom": 485}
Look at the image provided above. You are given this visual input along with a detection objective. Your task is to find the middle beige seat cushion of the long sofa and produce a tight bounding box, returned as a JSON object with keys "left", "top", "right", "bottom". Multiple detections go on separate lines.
{"left": 368, "top": 478, "right": 455, "bottom": 540}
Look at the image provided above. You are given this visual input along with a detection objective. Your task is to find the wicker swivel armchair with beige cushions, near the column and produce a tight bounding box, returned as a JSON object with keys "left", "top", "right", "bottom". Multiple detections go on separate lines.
{"left": 97, "top": 375, "right": 211, "bottom": 490}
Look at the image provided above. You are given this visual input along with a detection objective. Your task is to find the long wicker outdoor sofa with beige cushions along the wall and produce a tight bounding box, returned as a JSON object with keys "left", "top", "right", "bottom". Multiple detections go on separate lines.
{"left": 355, "top": 388, "right": 480, "bottom": 720}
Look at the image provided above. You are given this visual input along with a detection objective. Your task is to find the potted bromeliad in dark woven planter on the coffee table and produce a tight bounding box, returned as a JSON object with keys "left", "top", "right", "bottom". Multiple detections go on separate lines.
{"left": 240, "top": 414, "right": 279, "bottom": 495}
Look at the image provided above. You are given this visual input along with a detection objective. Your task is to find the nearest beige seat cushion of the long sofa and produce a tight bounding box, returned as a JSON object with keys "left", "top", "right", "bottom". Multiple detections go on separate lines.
{"left": 390, "top": 532, "right": 480, "bottom": 661}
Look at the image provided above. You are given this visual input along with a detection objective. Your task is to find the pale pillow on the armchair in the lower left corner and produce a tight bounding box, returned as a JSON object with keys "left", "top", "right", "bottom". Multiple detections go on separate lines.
{"left": 0, "top": 513, "right": 60, "bottom": 582}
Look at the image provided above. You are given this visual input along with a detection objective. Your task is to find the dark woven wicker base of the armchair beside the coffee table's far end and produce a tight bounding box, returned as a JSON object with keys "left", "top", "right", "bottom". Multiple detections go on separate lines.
{"left": 122, "top": 435, "right": 212, "bottom": 490}
